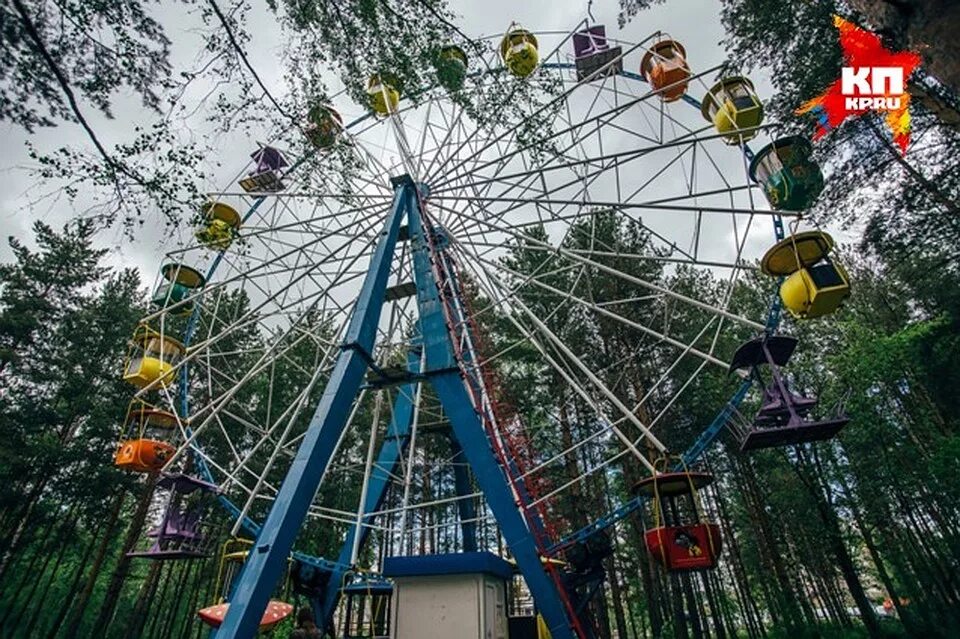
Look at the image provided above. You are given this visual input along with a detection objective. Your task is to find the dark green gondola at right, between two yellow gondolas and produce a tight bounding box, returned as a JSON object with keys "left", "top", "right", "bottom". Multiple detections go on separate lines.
{"left": 750, "top": 135, "right": 823, "bottom": 211}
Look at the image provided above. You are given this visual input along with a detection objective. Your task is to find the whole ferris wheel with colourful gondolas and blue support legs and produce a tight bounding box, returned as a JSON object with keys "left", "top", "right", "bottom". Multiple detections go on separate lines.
{"left": 117, "top": 18, "right": 849, "bottom": 638}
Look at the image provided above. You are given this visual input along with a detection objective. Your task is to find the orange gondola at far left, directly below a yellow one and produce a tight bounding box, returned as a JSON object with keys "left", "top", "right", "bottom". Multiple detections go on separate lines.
{"left": 113, "top": 399, "right": 178, "bottom": 473}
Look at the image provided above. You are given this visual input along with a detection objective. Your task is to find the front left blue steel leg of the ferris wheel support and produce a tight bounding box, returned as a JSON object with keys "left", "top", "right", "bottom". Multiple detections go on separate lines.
{"left": 215, "top": 182, "right": 414, "bottom": 639}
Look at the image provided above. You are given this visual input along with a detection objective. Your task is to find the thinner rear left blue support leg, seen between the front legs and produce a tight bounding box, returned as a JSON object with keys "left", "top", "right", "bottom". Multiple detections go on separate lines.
{"left": 317, "top": 338, "right": 422, "bottom": 628}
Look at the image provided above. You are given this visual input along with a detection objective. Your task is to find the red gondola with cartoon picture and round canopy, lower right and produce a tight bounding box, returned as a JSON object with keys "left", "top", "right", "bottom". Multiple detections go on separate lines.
{"left": 633, "top": 470, "right": 721, "bottom": 572}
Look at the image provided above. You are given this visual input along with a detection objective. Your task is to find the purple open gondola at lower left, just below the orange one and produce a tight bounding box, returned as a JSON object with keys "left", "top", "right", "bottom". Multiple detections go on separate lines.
{"left": 127, "top": 473, "right": 218, "bottom": 560}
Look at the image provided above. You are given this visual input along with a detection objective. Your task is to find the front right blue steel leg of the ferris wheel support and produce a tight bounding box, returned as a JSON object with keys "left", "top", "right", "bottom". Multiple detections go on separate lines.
{"left": 408, "top": 192, "right": 574, "bottom": 639}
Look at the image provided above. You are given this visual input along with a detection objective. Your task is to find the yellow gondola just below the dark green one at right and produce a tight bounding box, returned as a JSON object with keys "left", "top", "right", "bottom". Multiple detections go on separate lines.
{"left": 760, "top": 231, "right": 850, "bottom": 319}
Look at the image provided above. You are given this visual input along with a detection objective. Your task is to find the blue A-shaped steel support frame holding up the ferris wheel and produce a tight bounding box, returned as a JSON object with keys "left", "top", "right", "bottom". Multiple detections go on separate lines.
{"left": 212, "top": 178, "right": 574, "bottom": 639}
